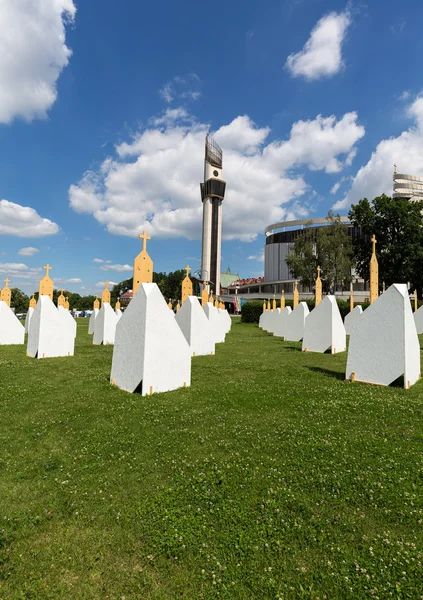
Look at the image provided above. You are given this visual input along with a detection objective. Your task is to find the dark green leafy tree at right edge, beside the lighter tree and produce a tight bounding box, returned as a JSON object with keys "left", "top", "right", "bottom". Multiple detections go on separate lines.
{"left": 349, "top": 194, "right": 423, "bottom": 298}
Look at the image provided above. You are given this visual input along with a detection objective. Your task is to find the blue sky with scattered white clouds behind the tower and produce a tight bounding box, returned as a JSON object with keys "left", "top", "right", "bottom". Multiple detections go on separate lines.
{"left": 0, "top": 0, "right": 423, "bottom": 294}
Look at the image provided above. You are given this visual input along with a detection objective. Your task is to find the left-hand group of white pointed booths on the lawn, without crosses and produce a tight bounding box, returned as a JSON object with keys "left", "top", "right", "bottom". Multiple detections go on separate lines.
{"left": 0, "top": 283, "right": 232, "bottom": 395}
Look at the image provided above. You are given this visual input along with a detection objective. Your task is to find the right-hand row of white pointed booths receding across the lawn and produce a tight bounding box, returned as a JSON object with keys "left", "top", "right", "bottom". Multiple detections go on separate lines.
{"left": 259, "top": 283, "right": 423, "bottom": 389}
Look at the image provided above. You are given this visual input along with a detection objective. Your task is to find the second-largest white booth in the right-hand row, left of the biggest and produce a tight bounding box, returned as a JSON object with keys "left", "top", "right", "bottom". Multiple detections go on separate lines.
{"left": 303, "top": 296, "right": 347, "bottom": 354}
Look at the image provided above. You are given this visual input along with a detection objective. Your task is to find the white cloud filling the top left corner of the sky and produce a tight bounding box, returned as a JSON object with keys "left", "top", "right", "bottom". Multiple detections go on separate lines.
{"left": 0, "top": 0, "right": 76, "bottom": 123}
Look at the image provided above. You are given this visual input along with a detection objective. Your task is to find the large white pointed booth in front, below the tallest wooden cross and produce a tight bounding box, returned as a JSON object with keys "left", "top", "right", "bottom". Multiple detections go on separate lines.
{"left": 110, "top": 283, "right": 192, "bottom": 396}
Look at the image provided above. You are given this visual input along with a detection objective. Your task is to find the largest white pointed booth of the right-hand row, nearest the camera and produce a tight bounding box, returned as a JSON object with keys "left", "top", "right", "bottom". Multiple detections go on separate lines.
{"left": 345, "top": 283, "right": 420, "bottom": 388}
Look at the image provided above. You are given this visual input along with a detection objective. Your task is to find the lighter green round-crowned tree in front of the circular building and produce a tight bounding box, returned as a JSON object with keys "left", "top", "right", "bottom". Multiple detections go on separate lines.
{"left": 286, "top": 211, "right": 352, "bottom": 293}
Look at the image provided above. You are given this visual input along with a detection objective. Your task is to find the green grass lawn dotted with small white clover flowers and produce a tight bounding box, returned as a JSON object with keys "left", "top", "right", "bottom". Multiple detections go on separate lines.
{"left": 0, "top": 320, "right": 423, "bottom": 600}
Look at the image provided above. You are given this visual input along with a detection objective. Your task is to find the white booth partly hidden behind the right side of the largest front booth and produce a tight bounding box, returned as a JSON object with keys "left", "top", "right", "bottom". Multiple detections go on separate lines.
{"left": 175, "top": 296, "right": 215, "bottom": 356}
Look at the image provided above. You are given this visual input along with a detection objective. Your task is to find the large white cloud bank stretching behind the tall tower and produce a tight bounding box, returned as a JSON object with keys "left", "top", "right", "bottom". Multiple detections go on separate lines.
{"left": 69, "top": 112, "right": 364, "bottom": 241}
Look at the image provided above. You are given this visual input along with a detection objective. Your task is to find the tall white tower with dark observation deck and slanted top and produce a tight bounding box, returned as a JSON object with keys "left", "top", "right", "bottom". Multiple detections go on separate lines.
{"left": 200, "top": 135, "right": 226, "bottom": 295}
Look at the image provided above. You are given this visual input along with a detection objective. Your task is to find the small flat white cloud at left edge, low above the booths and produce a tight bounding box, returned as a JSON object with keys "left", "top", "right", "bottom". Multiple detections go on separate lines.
{"left": 0, "top": 200, "right": 60, "bottom": 238}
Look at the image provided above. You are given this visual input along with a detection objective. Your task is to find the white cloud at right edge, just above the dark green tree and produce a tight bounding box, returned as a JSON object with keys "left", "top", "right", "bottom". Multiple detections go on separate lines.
{"left": 334, "top": 91, "right": 423, "bottom": 210}
